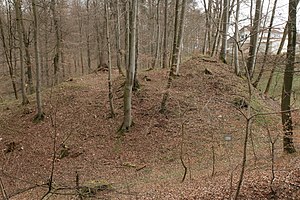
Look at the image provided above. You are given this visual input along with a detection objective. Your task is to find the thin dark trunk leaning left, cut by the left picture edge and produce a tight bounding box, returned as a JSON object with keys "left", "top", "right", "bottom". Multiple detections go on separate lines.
{"left": 0, "top": 16, "right": 18, "bottom": 99}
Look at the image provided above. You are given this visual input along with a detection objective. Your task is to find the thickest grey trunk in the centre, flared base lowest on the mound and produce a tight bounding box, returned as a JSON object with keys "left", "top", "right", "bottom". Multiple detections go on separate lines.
{"left": 120, "top": 0, "right": 137, "bottom": 132}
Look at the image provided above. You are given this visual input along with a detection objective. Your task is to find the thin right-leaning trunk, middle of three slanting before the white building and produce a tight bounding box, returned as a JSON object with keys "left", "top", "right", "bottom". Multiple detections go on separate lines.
{"left": 253, "top": 0, "right": 277, "bottom": 87}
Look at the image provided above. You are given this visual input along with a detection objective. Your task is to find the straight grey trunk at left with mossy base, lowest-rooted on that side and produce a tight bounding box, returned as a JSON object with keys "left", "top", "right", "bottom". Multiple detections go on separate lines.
{"left": 31, "top": 0, "right": 44, "bottom": 121}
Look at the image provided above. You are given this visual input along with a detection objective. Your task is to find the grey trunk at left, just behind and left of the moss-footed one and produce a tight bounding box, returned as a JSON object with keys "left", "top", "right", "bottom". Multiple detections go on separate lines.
{"left": 15, "top": 0, "right": 29, "bottom": 105}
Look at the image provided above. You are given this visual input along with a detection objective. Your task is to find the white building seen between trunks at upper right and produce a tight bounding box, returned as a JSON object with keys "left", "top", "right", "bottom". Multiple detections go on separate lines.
{"left": 228, "top": 26, "right": 288, "bottom": 54}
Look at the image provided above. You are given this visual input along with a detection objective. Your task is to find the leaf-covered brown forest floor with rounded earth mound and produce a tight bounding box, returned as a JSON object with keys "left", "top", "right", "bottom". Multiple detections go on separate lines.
{"left": 0, "top": 56, "right": 300, "bottom": 200}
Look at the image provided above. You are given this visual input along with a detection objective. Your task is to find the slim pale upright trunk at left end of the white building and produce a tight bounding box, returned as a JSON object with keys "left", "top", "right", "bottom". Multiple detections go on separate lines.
{"left": 234, "top": 0, "right": 241, "bottom": 76}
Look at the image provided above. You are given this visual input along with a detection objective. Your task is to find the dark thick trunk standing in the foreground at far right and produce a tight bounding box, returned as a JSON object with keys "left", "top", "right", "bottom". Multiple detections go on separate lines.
{"left": 281, "top": 0, "right": 297, "bottom": 153}
